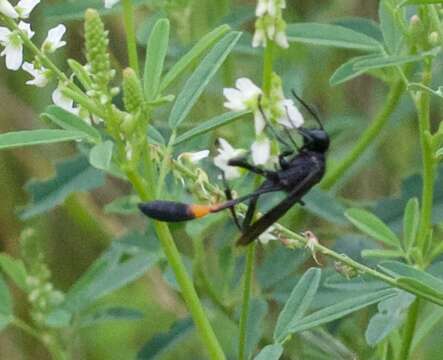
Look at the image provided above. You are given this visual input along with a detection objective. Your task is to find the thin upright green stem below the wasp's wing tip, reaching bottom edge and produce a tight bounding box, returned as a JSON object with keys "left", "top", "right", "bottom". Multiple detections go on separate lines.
{"left": 238, "top": 242, "right": 255, "bottom": 360}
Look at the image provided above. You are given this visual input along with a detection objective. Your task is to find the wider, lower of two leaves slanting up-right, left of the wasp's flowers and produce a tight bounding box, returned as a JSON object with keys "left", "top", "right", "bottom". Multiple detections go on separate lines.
{"left": 169, "top": 32, "right": 241, "bottom": 129}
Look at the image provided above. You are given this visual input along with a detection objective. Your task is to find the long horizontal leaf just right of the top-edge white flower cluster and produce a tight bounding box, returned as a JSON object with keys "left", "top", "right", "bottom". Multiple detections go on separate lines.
{"left": 287, "top": 23, "right": 382, "bottom": 52}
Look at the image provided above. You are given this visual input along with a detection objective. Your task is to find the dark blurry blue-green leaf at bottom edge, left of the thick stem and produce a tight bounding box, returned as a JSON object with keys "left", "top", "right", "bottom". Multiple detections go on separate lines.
{"left": 137, "top": 318, "right": 194, "bottom": 360}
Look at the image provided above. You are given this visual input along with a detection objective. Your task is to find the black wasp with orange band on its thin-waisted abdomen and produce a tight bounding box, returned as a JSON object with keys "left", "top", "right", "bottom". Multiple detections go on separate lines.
{"left": 139, "top": 91, "right": 329, "bottom": 245}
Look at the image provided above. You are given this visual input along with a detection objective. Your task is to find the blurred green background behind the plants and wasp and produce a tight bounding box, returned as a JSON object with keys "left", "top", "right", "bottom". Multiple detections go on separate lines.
{"left": 0, "top": 0, "right": 443, "bottom": 360}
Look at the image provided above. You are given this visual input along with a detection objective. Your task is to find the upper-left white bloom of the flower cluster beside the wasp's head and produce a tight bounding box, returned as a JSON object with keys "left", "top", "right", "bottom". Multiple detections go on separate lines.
{"left": 223, "top": 78, "right": 262, "bottom": 111}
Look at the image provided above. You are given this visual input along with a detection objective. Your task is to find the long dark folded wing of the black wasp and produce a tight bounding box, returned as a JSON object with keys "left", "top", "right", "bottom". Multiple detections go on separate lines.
{"left": 237, "top": 168, "right": 322, "bottom": 245}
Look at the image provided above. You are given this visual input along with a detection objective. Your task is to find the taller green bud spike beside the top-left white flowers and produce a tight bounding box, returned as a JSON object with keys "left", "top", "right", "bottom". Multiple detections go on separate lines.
{"left": 85, "top": 9, "right": 113, "bottom": 93}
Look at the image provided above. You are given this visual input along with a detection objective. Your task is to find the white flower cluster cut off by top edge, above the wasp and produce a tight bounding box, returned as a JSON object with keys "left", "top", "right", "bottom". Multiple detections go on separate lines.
{"left": 252, "top": 0, "right": 289, "bottom": 49}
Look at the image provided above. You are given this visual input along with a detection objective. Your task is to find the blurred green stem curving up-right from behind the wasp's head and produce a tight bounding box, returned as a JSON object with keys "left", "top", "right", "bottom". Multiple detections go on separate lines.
{"left": 321, "top": 81, "right": 404, "bottom": 190}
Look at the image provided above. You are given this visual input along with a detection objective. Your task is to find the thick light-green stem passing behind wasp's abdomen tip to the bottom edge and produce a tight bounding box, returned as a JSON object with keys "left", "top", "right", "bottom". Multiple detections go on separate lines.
{"left": 127, "top": 170, "right": 225, "bottom": 360}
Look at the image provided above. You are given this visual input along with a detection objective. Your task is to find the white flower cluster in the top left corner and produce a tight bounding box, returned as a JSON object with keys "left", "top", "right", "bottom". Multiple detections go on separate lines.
{"left": 0, "top": 0, "right": 83, "bottom": 114}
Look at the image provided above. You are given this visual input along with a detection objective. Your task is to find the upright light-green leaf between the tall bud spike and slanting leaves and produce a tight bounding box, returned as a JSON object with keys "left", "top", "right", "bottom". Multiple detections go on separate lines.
{"left": 143, "top": 19, "right": 169, "bottom": 101}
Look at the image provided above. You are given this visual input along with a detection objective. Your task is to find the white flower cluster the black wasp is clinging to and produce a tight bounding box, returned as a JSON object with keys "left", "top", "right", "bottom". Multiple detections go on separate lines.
{"left": 214, "top": 78, "right": 303, "bottom": 179}
